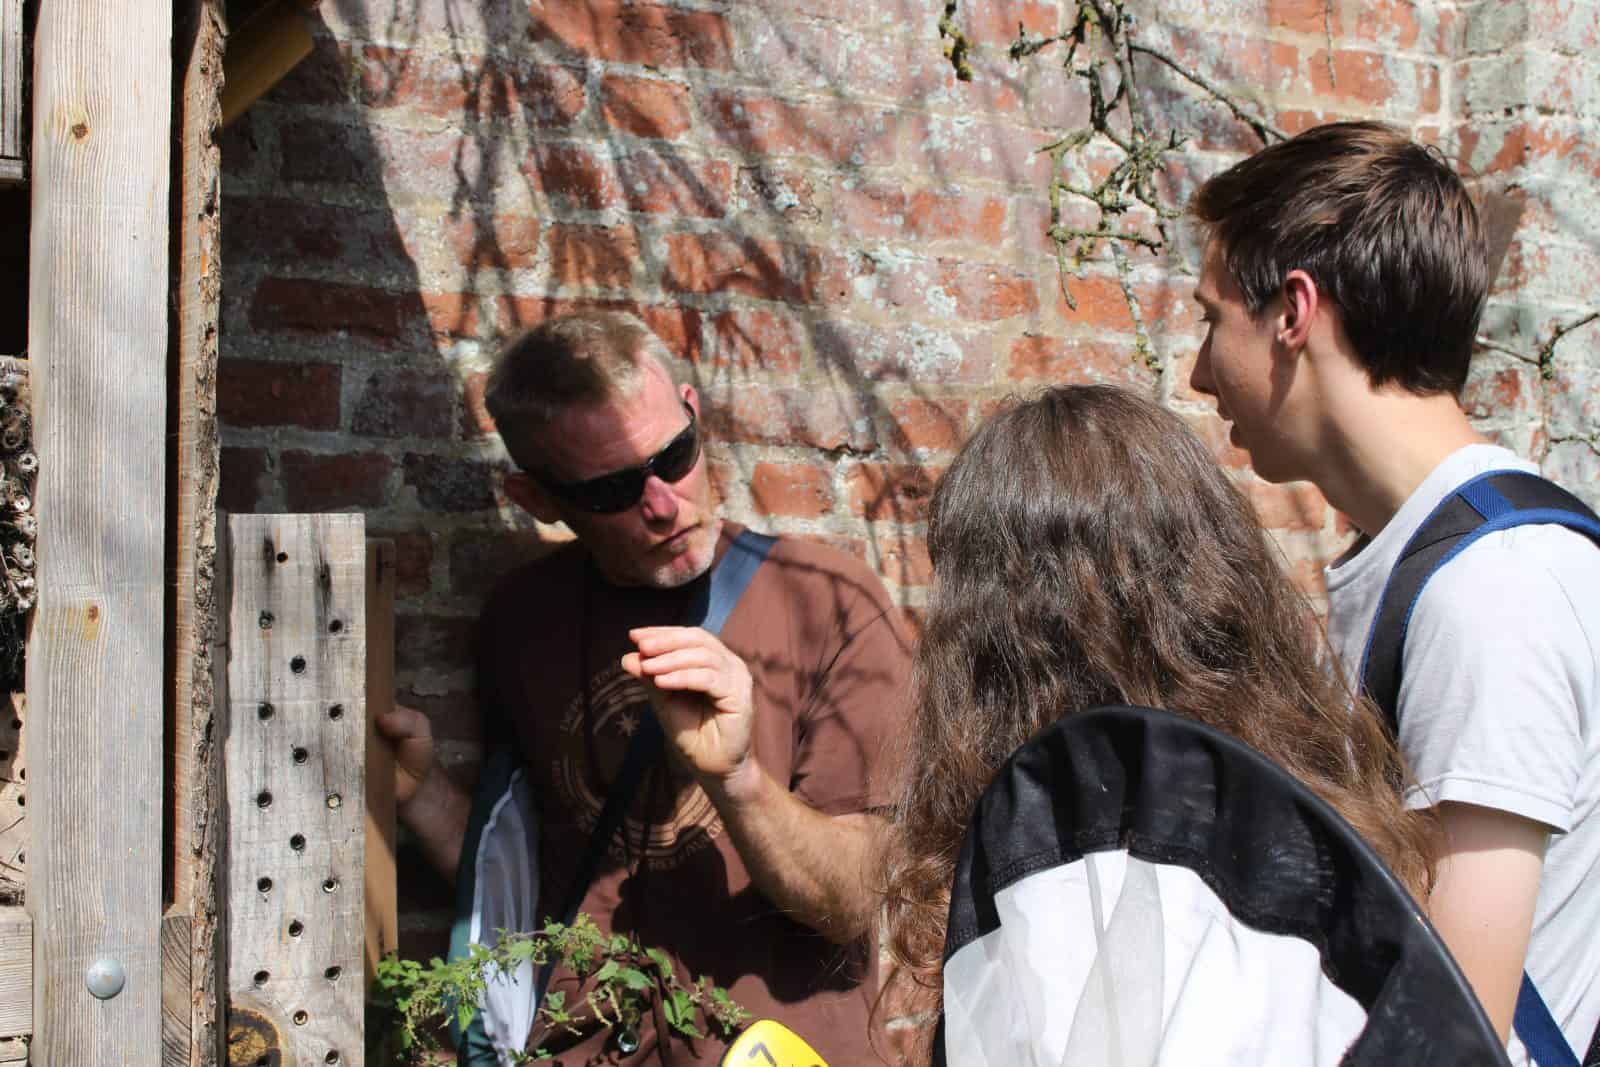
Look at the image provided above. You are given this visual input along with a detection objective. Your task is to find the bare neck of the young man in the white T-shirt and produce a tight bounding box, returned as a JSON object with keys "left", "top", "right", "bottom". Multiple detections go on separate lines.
{"left": 1314, "top": 387, "right": 1486, "bottom": 536}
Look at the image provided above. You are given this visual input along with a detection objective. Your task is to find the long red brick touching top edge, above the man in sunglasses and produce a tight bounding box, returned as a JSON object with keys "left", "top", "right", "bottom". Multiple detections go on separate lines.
{"left": 530, "top": 0, "right": 733, "bottom": 70}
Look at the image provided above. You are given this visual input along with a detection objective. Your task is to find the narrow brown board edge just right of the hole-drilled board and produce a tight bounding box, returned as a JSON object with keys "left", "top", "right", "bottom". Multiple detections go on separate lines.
{"left": 363, "top": 539, "right": 400, "bottom": 985}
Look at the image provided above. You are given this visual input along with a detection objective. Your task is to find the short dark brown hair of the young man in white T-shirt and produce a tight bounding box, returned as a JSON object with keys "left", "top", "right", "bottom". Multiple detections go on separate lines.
{"left": 1189, "top": 122, "right": 1490, "bottom": 395}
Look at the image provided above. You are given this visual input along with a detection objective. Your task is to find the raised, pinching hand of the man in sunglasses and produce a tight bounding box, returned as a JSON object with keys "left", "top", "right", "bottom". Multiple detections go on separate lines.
{"left": 622, "top": 625, "right": 758, "bottom": 792}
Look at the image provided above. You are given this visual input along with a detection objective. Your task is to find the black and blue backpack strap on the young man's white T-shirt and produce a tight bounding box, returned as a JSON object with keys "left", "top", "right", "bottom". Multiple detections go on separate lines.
{"left": 1362, "top": 470, "right": 1600, "bottom": 1067}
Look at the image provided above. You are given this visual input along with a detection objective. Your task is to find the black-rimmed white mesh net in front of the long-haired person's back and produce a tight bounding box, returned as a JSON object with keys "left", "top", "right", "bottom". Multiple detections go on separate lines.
{"left": 936, "top": 707, "right": 1507, "bottom": 1067}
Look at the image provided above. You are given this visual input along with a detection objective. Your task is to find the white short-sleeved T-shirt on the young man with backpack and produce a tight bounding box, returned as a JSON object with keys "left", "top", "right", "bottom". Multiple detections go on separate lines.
{"left": 1326, "top": 445, "right": 1600, "bottom": 1064}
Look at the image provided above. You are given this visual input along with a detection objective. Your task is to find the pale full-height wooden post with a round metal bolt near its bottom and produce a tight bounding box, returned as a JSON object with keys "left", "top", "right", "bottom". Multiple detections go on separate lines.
{"left": 27, "top": 0, "right": 173, "bottom": 1067}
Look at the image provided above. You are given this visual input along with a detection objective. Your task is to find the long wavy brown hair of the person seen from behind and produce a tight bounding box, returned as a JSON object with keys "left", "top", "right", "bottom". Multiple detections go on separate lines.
{"left": 877, "top": 386, "right": 1432, "bottom": 1062}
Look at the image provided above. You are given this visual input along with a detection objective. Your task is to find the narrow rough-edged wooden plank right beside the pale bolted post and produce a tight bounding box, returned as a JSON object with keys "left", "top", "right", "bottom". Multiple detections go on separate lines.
{"left": 163, "top": 0, "right": 226, "bottom": 1067}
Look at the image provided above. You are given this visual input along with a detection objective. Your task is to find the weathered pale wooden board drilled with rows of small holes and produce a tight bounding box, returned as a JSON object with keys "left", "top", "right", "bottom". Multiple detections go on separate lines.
{"left": 224, "top": 515, "right": 366, "bottom": 1064}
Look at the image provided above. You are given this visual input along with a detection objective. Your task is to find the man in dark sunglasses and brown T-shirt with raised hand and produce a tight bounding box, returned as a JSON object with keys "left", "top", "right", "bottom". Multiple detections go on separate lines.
{"left": 384, "top": 312, "right": 909, "bottom": 1064}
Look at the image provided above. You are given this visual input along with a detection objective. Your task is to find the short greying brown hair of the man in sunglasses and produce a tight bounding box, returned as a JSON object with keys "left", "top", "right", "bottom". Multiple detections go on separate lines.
{"left": 483, "top": 310, "right": 672, "bottom": 470}
